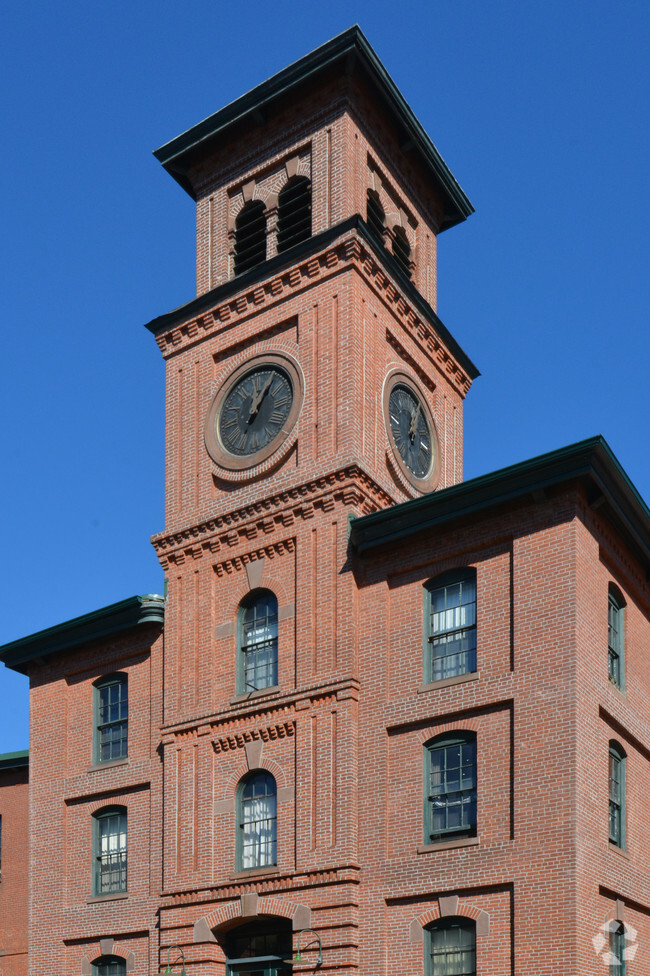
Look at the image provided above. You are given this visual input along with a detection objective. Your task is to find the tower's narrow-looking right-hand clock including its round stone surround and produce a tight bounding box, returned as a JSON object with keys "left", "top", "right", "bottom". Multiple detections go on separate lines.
{"left": 384, "top": 370, "right": 440, "bottom": 492}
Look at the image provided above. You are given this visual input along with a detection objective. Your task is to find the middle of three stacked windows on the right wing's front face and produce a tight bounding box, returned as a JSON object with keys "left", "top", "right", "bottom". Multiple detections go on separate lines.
{"left": 424, "top": 732, "right": 476, "bottom": 844}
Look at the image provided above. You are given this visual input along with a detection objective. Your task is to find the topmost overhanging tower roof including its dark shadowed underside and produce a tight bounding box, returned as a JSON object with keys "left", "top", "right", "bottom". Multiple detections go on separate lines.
{"left": 154, "top": 26, "right": 474, "bottom": 230}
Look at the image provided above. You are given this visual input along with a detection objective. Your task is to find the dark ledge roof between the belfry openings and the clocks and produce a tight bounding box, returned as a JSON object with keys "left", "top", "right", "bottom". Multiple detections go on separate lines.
{"left": 145, "top": 214, "right": 480, "bottom": 380}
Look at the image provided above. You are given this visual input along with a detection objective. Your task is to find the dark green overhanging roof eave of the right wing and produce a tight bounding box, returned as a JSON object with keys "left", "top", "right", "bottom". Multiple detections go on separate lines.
{"left": 350, "top": 437, "right": 650, "bottom": 570}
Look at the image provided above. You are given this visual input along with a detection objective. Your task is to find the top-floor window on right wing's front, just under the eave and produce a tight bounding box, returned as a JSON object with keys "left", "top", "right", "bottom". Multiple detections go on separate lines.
{"left": 424, "top": 569, "right": 476, "bottom": 682}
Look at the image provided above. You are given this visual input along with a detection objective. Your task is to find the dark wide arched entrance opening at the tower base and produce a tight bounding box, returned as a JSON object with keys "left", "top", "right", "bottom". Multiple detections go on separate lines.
{"left": 222, "top": 918, "right": 292, "bottom": 976}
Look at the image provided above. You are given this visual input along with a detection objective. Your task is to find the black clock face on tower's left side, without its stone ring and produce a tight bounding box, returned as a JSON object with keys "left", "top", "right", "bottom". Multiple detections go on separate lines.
{"left": 216, "top": 364, "right": 293, "bottom": 457}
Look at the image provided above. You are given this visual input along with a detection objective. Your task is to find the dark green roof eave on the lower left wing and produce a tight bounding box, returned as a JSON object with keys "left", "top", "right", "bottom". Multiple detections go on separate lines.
{"left": 0, "top": 594, "right": 165, "bottom": 674}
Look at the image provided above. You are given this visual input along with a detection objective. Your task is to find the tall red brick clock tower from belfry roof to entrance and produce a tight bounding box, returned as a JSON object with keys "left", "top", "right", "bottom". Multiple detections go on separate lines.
{"left": 143, "top": 27, "right": 477, "bottom": 972}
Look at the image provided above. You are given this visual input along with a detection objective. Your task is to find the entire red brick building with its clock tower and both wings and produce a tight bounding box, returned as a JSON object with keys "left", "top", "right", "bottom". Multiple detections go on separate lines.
{"left": 0, "top": 28, "right": 650, "bottom": 976}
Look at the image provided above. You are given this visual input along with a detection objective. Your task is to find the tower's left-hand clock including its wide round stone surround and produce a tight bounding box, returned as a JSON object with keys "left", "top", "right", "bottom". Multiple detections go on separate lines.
{"left": 205, "top": 354, "right": 303, "bottom": 471}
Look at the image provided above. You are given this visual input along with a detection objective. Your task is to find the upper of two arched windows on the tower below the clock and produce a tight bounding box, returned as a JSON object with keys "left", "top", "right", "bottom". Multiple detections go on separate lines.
{"left": 237, "top": 590, "right": 278, "bottom": 694}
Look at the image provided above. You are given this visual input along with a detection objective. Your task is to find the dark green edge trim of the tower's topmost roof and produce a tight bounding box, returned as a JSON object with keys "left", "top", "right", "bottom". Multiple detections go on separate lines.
{"left": 154, "top": 25, "right": 474, "bottom": 230}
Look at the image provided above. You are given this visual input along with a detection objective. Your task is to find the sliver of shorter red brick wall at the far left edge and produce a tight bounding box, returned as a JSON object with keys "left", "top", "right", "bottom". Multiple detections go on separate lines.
{"left": 0, "top": 768, "right": 29, "bottom": 976}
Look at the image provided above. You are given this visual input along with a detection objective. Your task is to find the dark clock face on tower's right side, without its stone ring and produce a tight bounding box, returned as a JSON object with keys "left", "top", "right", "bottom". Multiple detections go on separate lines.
{"left": 387, "top": 382, "right": 435, "bottom": 479}
